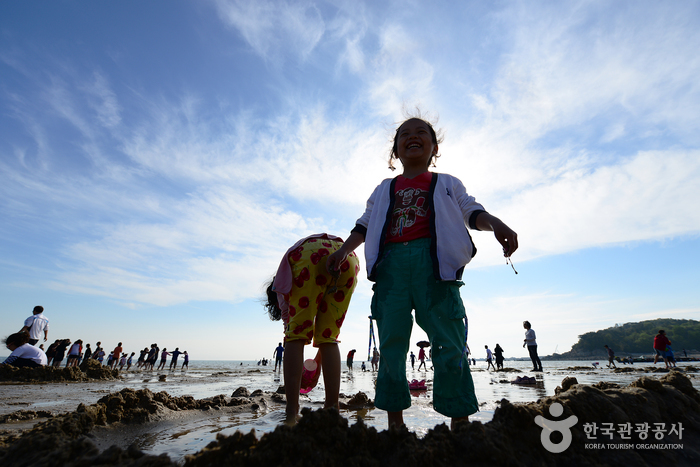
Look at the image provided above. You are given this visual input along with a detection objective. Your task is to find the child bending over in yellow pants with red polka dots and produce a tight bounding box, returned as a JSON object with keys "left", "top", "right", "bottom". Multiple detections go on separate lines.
{"left": 265, "top": 234, "right": 360, "bottom": 422}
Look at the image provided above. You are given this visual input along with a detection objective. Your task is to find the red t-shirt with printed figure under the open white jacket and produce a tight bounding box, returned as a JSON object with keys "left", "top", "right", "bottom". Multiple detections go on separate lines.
{"left": 386, "top": 172, "right": 433, "bottom": 242}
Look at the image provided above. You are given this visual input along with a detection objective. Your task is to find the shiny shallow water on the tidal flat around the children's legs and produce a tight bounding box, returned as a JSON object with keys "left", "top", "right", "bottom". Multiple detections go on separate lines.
{"left": 101, "top": 361, "right": 700, "bottom": 460}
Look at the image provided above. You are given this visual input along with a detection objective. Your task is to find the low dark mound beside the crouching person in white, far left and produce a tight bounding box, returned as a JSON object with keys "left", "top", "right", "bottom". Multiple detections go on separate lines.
{"left": 0, "top": 359, "right": 119, "bottom": 383}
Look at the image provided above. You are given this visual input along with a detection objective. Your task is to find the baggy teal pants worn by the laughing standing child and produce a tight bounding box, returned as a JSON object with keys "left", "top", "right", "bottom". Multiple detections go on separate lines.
{"left": 372, "top": 239, "right": 479, "bottom": 417}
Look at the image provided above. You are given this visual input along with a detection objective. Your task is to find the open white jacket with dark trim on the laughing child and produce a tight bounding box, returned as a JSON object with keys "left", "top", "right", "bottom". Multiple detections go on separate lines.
{"left": 353, "top": 173, "right": 485, "bottom": 281}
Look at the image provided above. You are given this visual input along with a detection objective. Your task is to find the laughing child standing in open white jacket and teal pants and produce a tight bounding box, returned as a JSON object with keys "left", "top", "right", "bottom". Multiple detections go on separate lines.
{"left": 327, "top": 114, "right": 518, "bottom": 427}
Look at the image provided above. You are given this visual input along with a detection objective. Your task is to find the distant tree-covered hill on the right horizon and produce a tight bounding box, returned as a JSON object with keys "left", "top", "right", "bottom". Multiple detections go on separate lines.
{"left": 554, "top": 318, "right": 700, "bottom": 359}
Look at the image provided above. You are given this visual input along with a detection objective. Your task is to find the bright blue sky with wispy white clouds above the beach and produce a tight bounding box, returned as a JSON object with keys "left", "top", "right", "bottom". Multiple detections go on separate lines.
{"left": 0, "top": 0, "right": 700, "bottom": 360}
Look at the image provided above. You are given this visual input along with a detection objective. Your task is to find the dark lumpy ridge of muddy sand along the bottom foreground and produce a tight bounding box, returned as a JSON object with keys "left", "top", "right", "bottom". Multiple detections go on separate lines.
{"left": 0, "top": 371, "right": 700, "bottom": 467}
